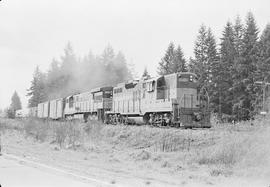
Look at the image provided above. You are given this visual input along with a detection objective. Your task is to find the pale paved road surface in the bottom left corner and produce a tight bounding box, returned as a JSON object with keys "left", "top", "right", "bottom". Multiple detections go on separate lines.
{"left": 0, "top": 156, "right": 116, "bottom": 187}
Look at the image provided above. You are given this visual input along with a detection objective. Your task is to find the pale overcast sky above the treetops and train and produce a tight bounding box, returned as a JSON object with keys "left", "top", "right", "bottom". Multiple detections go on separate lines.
{"left": 0, "top": 0, "right": 270, "bottom": 108}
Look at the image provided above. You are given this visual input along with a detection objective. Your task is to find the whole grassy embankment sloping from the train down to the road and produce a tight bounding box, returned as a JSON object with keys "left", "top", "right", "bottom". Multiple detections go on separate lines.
{"left": 0, "top": 119, "right": 270, "bottom": 186}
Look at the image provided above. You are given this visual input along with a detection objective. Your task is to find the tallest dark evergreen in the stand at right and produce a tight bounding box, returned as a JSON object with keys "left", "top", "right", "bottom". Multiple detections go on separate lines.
{"left": 234, "top": 12, "right": 259, "bottom": 119}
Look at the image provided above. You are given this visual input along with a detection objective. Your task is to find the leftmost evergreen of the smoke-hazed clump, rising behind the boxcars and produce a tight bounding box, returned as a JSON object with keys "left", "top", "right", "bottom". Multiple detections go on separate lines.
{"left": 27, "top": 67, "right": 47, "bottom": 107}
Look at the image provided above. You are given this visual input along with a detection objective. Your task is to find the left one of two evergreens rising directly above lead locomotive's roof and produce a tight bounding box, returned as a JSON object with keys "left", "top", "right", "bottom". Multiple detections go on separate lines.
{"left": 158, "top": 42, "right": 175, "bottom": 75}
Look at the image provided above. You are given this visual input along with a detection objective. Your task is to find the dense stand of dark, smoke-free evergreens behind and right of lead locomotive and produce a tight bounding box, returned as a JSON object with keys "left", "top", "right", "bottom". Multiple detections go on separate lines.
{"left": 158, "top": 12, "right": 270, "bottom": 120}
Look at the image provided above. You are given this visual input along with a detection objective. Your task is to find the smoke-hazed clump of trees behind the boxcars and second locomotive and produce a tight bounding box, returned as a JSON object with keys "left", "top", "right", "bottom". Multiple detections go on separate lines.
{"left": 27, "top": 43, "right": 132, "bottom": 107}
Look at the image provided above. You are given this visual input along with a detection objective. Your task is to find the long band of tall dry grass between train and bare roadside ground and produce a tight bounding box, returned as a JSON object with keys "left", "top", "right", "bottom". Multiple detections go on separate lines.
{"left": 0, "top": 117, "right": 270, "bottom": 176}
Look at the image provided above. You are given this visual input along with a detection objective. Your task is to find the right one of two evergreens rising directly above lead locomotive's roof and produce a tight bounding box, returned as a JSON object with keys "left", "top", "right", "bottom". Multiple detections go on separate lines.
{"left": 170, "top": 45, "right": 187, "bottom": 73}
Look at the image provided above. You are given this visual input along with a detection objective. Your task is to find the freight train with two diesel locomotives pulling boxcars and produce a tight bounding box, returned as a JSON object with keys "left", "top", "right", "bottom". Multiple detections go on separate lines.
{"left": 25, "top": 72, "right": 211, "bottom": 128}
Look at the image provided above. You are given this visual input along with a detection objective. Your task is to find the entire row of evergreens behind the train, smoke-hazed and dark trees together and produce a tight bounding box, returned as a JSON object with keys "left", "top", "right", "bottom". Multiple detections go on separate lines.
{"left": 24, "top": 12, "right": 270, "bottom": 120}
